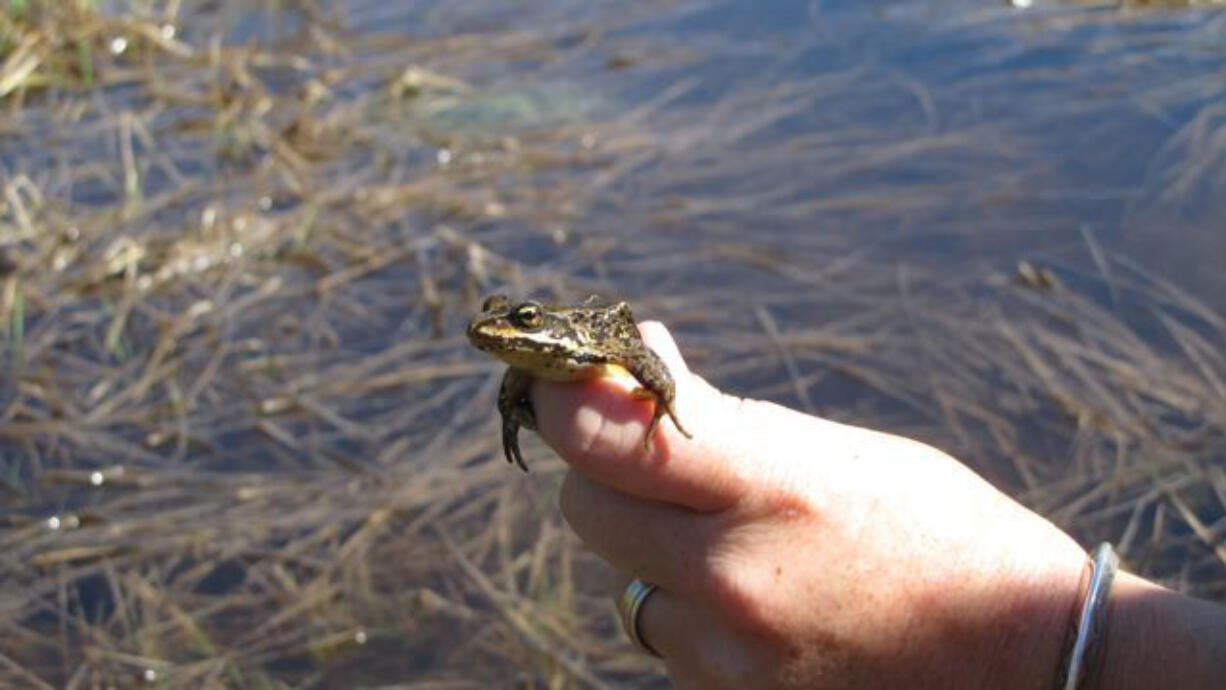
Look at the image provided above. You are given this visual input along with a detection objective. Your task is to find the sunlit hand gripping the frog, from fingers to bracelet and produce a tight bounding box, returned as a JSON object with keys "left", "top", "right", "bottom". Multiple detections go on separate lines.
{"left": 532, "top": 322, "right": 1085, "bottom": 689}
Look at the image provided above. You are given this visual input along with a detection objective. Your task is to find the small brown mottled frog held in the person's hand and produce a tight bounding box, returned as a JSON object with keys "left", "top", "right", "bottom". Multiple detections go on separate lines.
{"left": 467, "top": 294, "right": 693, "bottom": 472}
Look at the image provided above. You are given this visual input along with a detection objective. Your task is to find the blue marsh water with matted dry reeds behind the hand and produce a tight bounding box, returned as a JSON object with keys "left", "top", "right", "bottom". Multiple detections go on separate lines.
{"left": 0, "top": 0, "right": 1226, "bottom": 688}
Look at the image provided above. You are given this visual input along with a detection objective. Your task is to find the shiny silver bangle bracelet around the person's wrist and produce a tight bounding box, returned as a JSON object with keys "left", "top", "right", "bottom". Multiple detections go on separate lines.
{"left": 1056, "top": 542, "right": 1119, "bottom": 690}
